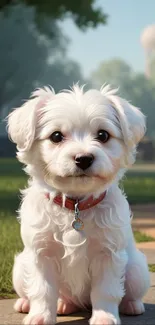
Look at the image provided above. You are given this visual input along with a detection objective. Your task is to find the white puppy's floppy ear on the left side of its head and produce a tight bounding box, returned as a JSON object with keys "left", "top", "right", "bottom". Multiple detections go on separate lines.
{"left": 7, "top": 87, "right": 54, "bottom": 151}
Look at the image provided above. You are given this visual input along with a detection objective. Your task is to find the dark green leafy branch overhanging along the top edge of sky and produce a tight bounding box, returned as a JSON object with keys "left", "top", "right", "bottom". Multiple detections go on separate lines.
{"left": 0, "top": 0, "right": 107, "bottom": 38}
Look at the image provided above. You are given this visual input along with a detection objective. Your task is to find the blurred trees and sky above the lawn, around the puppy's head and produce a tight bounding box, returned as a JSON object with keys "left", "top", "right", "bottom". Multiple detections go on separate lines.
{"left": 0, "top": 0, "right": 155, "bottom": 158}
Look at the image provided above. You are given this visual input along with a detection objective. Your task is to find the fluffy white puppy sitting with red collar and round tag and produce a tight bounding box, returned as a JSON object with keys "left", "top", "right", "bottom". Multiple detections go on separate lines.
{"left": 8, "top": 85, "right": 149, "bottom": 325}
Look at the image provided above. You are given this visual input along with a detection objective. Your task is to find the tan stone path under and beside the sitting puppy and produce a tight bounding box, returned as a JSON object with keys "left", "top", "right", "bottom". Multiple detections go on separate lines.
{"left": 0, "top": 205, "right": 155, "bottom": 325}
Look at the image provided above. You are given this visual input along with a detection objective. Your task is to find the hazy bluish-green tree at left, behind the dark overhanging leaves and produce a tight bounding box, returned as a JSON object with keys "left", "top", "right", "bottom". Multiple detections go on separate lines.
{"left": 0, "top": 5, "right": 83, "bottom": 124}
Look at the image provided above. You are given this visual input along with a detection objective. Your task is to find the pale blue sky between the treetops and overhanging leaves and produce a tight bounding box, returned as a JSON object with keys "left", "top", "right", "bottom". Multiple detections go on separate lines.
{"left": 60, "top": 0, "right": 155, "bottom": 77}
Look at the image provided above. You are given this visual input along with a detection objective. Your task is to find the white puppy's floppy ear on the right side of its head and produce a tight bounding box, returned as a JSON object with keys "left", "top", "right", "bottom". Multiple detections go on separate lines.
{"left": 101, "top": 88, "right": 146, "bottom": 147}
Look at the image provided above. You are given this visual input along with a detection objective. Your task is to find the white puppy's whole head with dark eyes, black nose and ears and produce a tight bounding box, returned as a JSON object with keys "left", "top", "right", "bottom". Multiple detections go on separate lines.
{"left": 8, "top": 86, "right": 145, "bottom": 195}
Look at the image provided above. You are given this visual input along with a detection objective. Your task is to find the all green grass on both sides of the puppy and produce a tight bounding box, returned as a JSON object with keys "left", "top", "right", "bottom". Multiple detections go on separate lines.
{"left": 0, "top": 159, "right": 155, "bottom": 297}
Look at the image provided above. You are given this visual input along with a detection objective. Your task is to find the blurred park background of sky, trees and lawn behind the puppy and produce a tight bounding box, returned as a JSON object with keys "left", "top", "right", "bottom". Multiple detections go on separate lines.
{"left": 0, "top": 0, "right": 155, "bottom": 297}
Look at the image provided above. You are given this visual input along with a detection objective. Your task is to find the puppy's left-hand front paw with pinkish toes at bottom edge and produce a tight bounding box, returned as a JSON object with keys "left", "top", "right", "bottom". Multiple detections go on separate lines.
{"left": 23, "top": 313, "right": 56, "bottom": 325}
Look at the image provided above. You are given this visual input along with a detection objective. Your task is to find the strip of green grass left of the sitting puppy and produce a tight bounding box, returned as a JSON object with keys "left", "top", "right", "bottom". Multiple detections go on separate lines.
{"left": 0, "top": 159, "right": 26, "bottom": 298}
